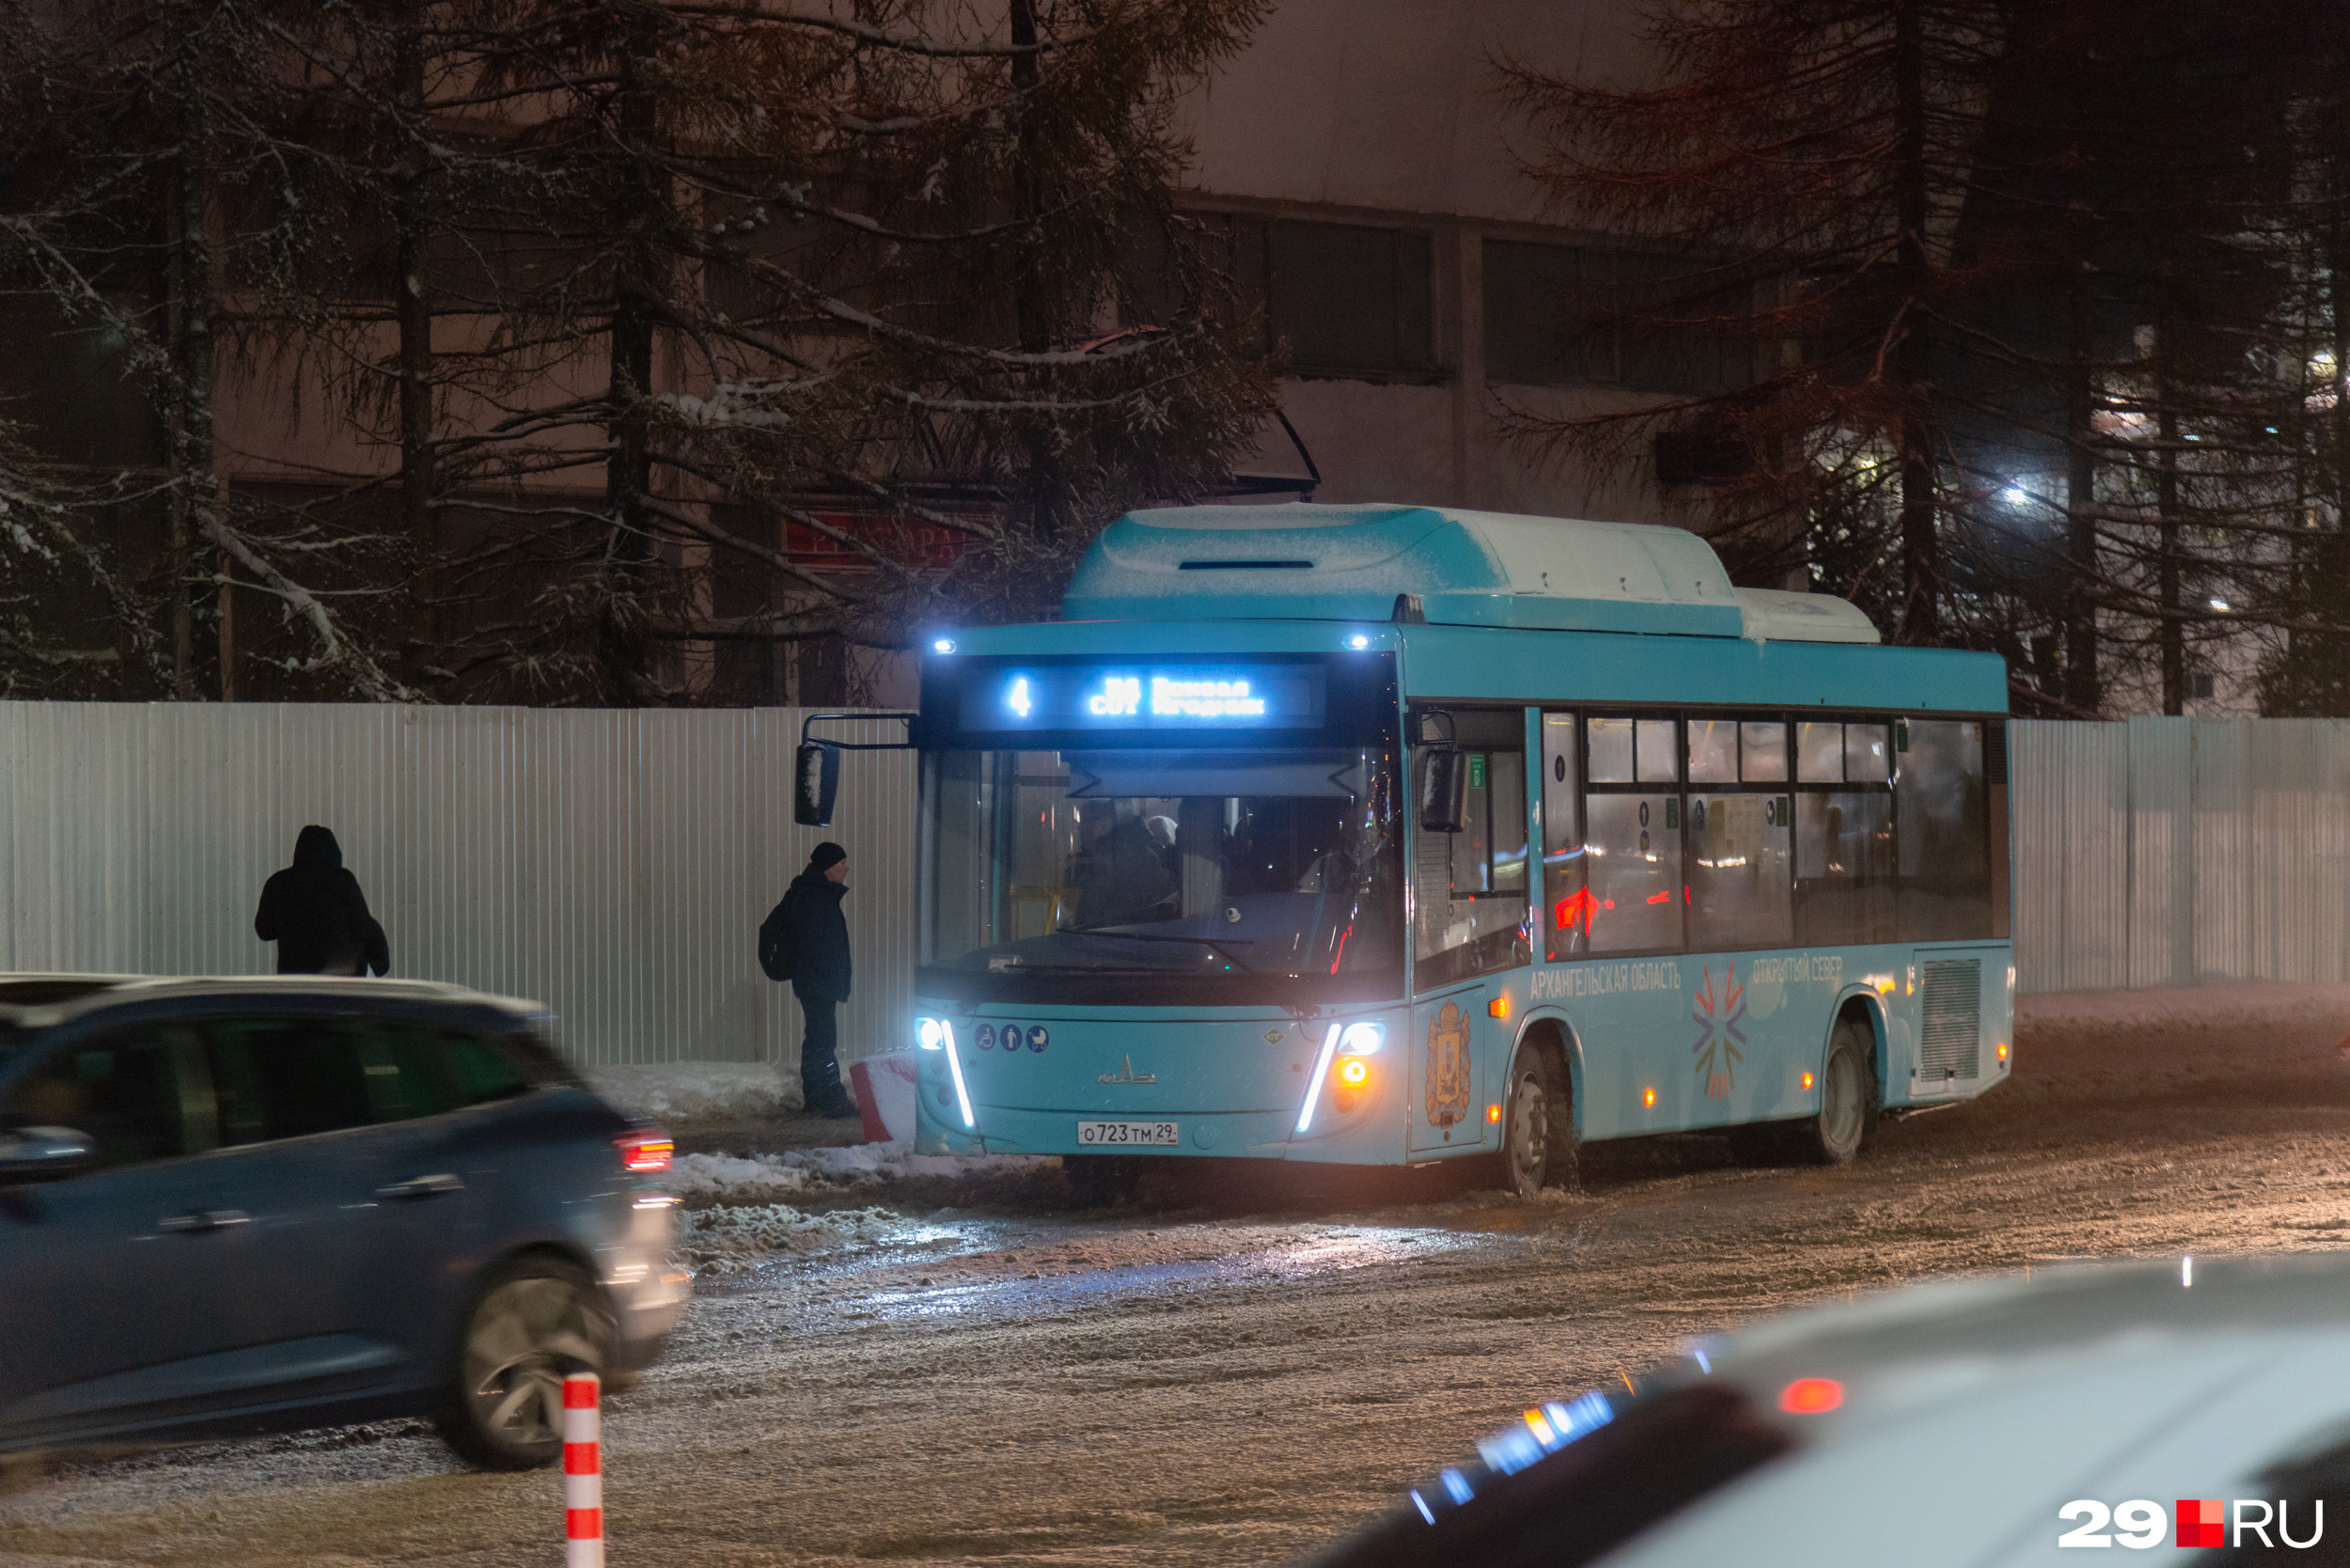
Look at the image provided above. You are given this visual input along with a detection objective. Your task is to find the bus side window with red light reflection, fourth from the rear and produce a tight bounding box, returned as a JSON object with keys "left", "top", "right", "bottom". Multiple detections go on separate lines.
{"left": 1584, "top": 719, "right": 1683, "bottom": 952}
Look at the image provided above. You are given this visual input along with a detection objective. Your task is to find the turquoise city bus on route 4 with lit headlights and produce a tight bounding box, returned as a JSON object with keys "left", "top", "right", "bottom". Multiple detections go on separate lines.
{"left": 884, "top": 506, "right": 2014, "bottom": 1194}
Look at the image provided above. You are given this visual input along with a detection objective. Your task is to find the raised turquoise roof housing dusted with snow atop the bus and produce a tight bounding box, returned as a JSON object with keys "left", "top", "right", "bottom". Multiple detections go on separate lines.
{"left": 1062, "top": 503, "right": 1878, "bottom": 642}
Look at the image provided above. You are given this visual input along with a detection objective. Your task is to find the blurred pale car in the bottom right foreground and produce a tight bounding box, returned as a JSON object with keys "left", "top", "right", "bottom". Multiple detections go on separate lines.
{"left": 1314, "top": 1253, "right": 2350, "bottom": 1568}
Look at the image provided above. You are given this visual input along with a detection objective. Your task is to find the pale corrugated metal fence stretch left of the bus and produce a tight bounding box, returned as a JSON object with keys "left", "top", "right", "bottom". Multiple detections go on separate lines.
{"left": 0, "top": 703, "right": 916, "bottom": 1081}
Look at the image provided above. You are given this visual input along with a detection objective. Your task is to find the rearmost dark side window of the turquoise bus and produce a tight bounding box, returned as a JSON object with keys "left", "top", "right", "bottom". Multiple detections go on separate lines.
{"left": 1894, "top": 719, "right": 1993, "bottom": 943}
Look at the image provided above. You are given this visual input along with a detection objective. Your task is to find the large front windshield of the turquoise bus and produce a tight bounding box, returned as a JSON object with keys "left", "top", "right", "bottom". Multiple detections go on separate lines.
{"left": 924, "top": 747, "right": 1403, "bottom": 999}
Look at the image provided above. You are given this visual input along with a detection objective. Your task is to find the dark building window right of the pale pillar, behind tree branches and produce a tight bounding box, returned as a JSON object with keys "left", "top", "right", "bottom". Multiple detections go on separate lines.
{"left": 1485, "top": 240, "right": 1751, "bottom": 393}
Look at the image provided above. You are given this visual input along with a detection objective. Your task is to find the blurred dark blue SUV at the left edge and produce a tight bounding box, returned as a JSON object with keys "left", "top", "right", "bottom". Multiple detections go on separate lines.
{"left": 0, "top": 976, "right": 689, "bottom": 1469}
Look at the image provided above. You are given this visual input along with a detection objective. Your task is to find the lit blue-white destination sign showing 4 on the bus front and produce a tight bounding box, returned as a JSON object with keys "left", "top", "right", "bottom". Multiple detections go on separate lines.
{"left": 962, "top": 666, "right": 1324, "bottom": 729}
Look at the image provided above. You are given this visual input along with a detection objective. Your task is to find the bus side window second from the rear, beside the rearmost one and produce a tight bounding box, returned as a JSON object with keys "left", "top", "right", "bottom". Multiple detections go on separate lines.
{"left": 1795, "top": 722, "right": 1894, "bottom": 948}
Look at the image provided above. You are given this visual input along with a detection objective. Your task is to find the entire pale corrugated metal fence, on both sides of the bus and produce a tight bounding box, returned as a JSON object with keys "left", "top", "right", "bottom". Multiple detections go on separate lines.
{"left": 0, "top": 703, "right": 2350, "bottom": 1065}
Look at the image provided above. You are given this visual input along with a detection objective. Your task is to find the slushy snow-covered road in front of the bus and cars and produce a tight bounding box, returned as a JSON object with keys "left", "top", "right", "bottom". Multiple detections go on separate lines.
{"left": 0, "top": 987, "right": 2350, "bottom": 1568}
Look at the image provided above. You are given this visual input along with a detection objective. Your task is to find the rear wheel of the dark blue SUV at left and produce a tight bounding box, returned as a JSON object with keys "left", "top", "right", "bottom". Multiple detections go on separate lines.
{"left": 435, "top": 1258, "right": 619, "bottom": 1469}
